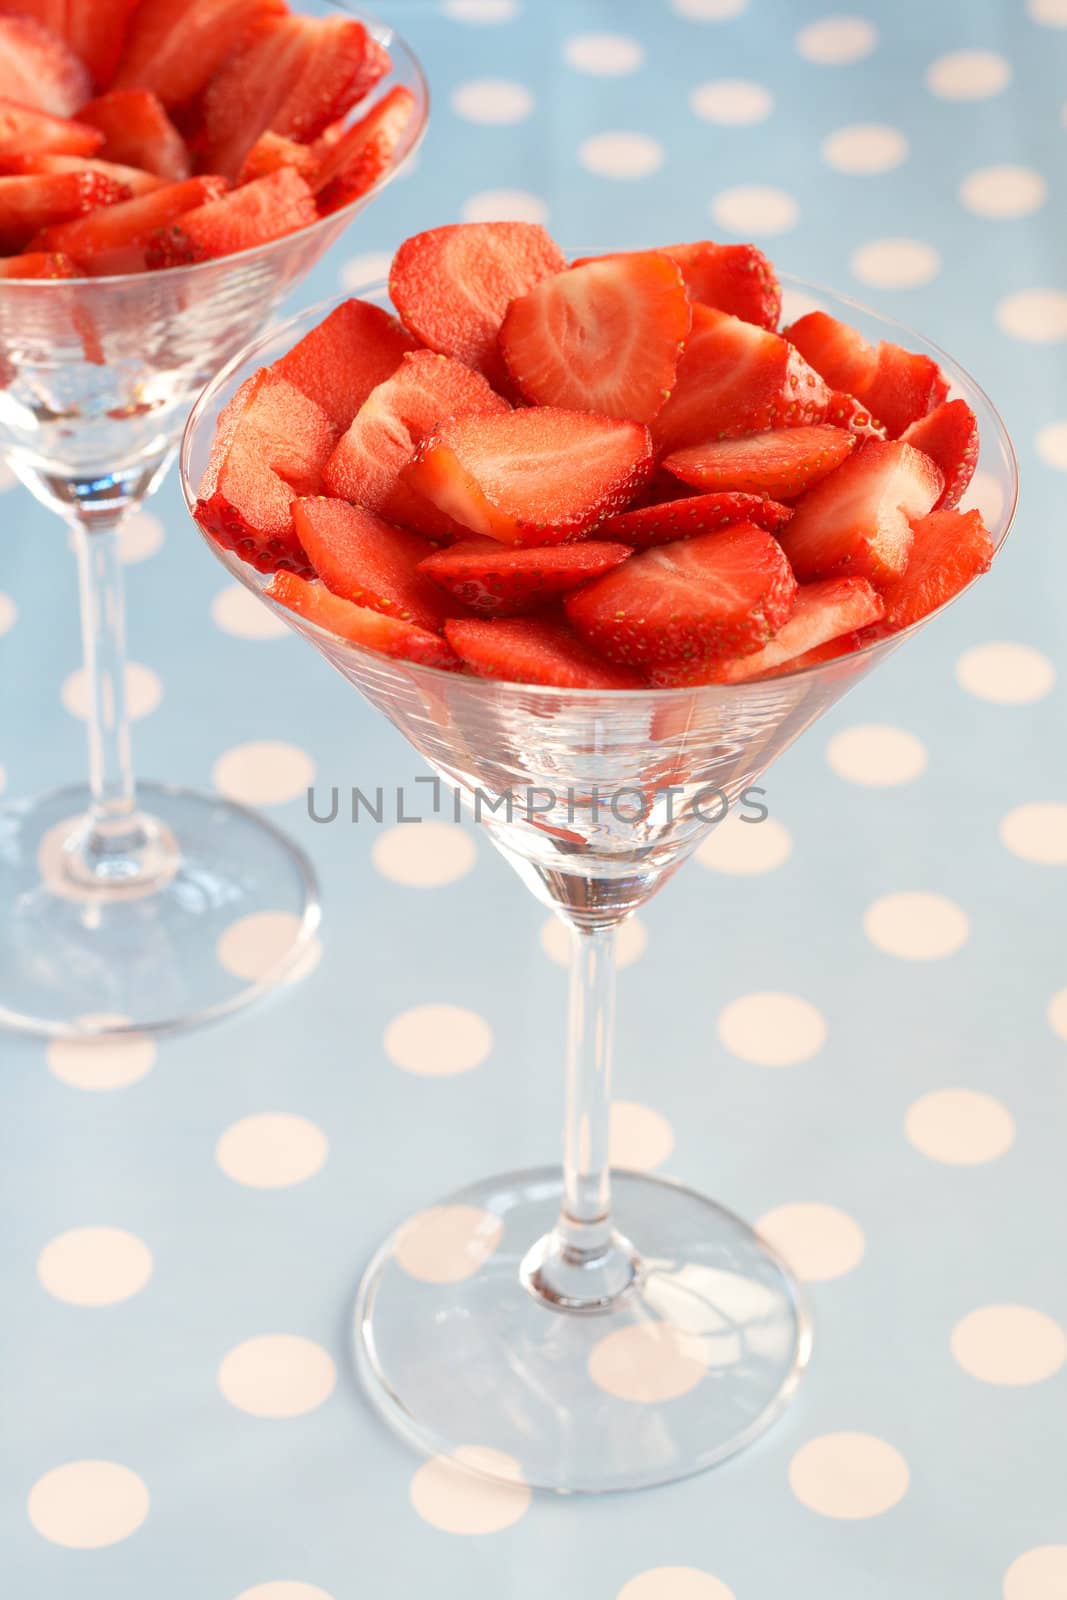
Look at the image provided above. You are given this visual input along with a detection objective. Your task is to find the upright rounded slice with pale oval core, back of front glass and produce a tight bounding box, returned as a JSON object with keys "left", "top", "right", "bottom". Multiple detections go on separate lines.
{"left": 499, "top": 250, "right": 693, "bottom": 422}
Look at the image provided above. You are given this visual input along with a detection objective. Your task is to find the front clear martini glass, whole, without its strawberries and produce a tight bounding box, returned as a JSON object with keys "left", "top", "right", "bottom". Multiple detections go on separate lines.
{"left": 182, "top": 275, "right": 1017, "bottom": 1491}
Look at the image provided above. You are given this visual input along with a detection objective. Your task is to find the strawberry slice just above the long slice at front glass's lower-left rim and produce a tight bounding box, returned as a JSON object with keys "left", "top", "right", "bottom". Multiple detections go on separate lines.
{"left": 293, "top": 496, "right": 450, "bottom": 634}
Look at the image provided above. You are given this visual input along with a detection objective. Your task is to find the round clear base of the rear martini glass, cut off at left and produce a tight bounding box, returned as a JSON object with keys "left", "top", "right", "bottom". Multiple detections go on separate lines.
{"left": 0, "top": 784, "right": 320, "bottom": 1038}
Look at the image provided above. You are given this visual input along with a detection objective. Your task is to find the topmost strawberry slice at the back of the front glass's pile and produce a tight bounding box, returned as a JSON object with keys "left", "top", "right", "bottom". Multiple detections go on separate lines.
{"left": 389, "top": 222, "right": 566, "bottom": 382}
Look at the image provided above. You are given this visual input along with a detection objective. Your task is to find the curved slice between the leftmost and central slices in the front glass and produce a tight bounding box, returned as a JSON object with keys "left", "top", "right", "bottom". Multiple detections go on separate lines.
{"left": 325, "top": 350, "right": 509, "bottom": 538}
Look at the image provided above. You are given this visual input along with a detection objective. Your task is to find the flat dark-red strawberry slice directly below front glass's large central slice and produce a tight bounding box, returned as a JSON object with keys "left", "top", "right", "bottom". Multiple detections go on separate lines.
{"left": 421, "top": 539, "right": 630, "bottom": 616}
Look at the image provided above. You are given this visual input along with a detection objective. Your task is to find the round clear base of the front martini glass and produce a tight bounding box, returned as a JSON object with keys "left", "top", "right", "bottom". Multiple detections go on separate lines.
{"left": 354, "top": 1166, "right": 811, "bottom": 1493}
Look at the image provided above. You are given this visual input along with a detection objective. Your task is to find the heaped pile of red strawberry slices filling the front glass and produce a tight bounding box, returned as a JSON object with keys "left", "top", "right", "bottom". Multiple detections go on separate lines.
{"left": 197, "top": 222, "right": 993, "bottom": 690}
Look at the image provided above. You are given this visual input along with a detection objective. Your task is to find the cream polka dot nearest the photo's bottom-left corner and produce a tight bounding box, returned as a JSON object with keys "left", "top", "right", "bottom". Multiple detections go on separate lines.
{"left": 26, "top": 1461, "right": 149, "bottom": 1550}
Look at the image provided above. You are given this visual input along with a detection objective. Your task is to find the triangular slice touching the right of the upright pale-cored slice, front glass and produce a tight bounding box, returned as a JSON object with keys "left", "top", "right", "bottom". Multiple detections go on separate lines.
{"left": 653, "top": 306, "right": 830, "bottom": 451}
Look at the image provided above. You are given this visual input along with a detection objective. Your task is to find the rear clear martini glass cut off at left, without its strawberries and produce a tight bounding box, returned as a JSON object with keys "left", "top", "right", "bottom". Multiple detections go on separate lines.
{"left": 0, "top": 6, "right": 427, "bottom": 1037}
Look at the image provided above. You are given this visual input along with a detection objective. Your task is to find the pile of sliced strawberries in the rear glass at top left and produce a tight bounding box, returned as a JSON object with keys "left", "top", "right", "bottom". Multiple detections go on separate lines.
{"left": 0, "top": 0, "right": 414, "bottom": 278}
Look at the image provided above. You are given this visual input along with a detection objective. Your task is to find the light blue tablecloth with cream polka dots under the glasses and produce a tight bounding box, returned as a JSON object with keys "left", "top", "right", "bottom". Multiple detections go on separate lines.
{"left": 0, "top": 0, "right": 1067, "bottom": 1600}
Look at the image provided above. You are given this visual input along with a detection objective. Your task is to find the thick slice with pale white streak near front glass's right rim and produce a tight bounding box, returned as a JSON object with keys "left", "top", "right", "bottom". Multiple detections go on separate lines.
{"left": 781, "top": 438, "right": 942, "bottom": 584}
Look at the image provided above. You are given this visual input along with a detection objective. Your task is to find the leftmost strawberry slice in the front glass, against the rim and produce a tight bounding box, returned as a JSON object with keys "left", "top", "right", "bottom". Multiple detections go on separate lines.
{"left": 195, "top": 368, "right": 338, "bottom": 573}
